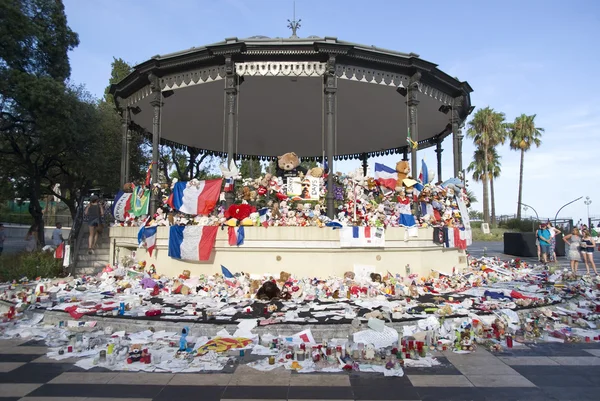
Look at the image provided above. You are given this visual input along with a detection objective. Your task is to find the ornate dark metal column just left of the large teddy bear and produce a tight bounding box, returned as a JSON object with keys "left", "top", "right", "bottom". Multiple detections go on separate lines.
{"left": 225, "top": 54, "right": 238, "bottom": 206}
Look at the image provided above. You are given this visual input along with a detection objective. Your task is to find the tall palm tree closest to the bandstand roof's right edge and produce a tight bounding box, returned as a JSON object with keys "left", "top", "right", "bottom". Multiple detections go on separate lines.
{"left": 467, "top": 106, "right": 507, "bottom": 223}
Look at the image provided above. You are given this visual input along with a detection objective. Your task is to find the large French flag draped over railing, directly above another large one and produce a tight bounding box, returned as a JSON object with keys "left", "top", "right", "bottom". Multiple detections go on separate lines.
{"left": 167, "top": 178, "right": 223, "bottom": 216}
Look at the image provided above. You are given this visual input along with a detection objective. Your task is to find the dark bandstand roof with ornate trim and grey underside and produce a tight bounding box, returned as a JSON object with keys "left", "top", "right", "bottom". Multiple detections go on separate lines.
{"left": 110, "top": 36, "right": 472, "bottom": 158}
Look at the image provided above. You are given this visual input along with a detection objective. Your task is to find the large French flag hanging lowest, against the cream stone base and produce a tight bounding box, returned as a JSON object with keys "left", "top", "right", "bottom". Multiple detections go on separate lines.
{"left": 169, "top": 226, "right": 219, "bottom": 261}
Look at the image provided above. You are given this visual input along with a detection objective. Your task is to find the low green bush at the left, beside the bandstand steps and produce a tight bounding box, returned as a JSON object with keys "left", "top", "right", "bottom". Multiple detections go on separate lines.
{"left": 0, "top": 252, "right": 63, "bottom": 282}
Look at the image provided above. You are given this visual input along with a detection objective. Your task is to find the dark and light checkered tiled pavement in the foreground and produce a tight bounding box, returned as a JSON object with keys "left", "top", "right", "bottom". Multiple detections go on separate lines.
{"left": 0, "top": 340, "right": 600, "bottom": 401}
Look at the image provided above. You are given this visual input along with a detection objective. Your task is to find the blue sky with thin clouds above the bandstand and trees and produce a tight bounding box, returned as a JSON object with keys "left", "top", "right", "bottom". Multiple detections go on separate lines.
{"left": 64, "top": 0, "right": 600, "bottom": 219}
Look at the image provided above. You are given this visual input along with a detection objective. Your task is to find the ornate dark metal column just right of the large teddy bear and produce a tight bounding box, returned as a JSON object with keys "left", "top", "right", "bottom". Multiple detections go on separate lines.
{"left": 325, "top": 54, "right": 337, "bottom": 219}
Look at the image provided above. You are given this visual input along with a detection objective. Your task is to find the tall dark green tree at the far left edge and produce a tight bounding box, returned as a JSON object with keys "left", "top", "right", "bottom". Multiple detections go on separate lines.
{"left": 0, "top": 0, "right": 79, "bottom": 244}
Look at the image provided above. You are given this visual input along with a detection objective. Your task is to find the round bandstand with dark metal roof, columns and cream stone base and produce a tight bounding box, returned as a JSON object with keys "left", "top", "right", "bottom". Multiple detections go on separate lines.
{"left": 110, "top": 35, "right": 473, "bottom": 274}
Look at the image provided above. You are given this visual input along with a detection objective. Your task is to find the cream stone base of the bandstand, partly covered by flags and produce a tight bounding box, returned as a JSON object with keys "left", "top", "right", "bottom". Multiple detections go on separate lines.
{"left": 110, "top": 227, "right": 467, "bottom": 278}
